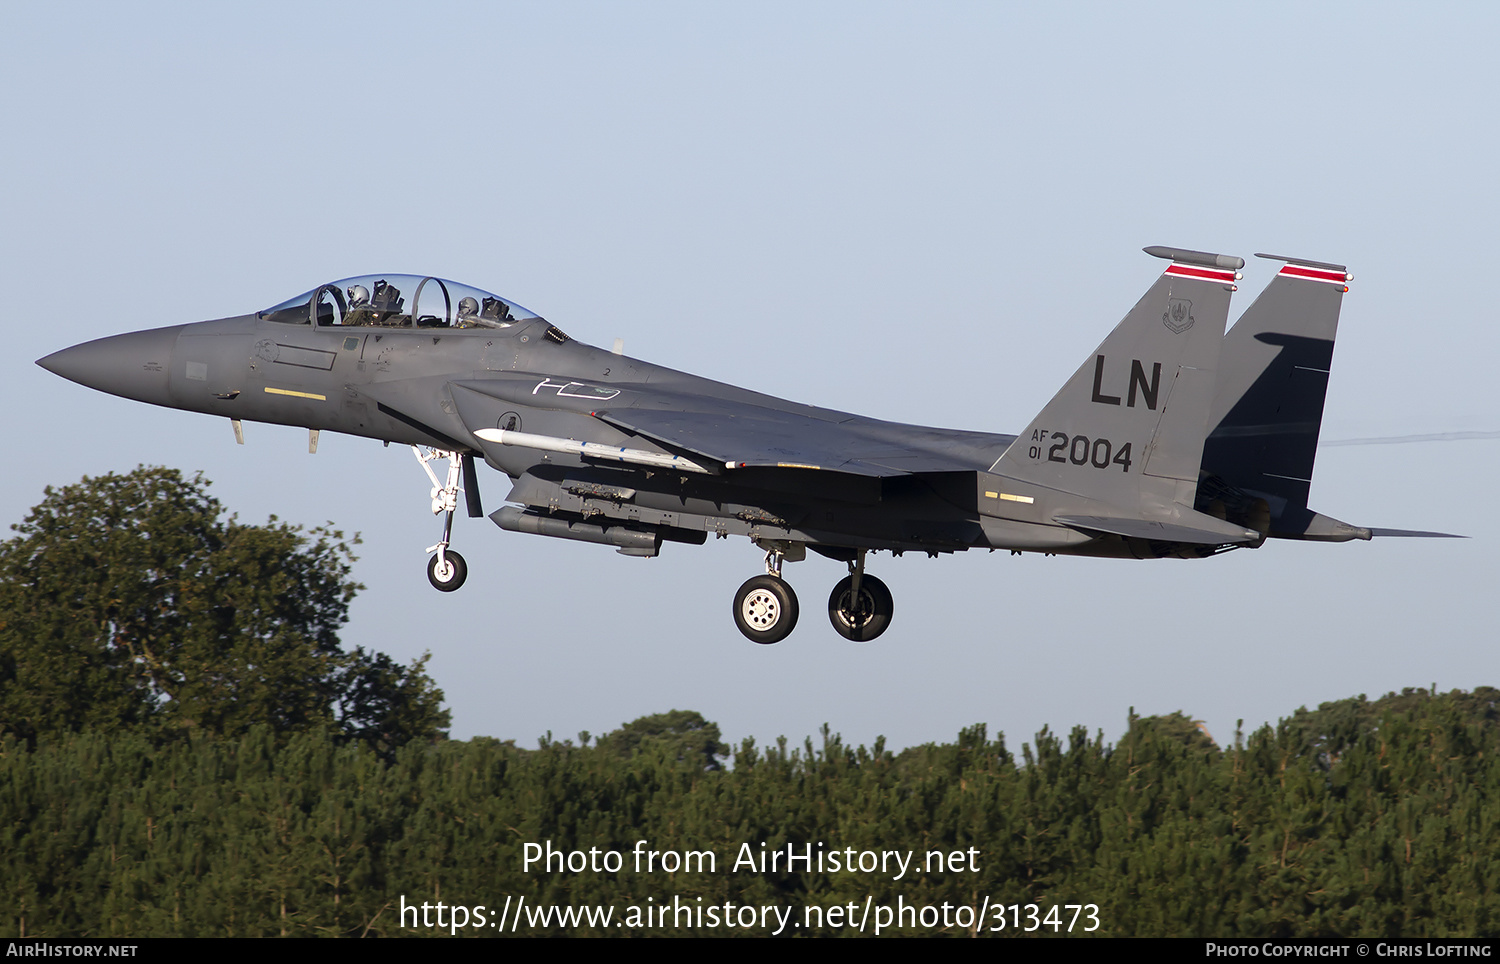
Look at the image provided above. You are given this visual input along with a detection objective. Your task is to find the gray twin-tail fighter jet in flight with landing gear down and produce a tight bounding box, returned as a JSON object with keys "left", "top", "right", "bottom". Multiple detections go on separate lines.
{"left": 38, "top": 247, "right": 1442, "bottom": 643}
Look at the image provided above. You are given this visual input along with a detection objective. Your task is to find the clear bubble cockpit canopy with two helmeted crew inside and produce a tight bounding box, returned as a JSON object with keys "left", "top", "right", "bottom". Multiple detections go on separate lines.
{"left": 260, "top": 274, "right": 539, "bottom": 328}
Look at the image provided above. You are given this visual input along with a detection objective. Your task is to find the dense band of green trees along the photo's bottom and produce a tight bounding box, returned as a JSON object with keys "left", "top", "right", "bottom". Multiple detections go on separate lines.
{"left": 0, "top": 690, "right": 1500, "bottom": 939}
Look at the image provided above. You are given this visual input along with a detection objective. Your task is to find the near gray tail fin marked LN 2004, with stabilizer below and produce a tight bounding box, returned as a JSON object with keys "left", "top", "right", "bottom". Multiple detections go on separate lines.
{"left": 990, "top": 247, "right": 1259, "bottom": 544}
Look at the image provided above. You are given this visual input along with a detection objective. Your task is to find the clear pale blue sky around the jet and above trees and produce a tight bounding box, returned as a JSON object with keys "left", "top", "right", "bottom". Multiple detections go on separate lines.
{"left": 0, "top": 3, "right": 1500, "bottom": 747}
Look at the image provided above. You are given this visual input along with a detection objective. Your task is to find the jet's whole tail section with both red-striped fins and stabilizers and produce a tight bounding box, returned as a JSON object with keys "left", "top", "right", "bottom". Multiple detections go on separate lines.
{"left": 980, "top": 247, "right": 1449, "bottom": 555}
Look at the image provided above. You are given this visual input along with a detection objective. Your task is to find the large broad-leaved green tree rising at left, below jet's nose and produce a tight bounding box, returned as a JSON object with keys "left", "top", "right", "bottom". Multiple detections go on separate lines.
{"left": 0, "top": 466, "right": 447, "bottom": 751}
